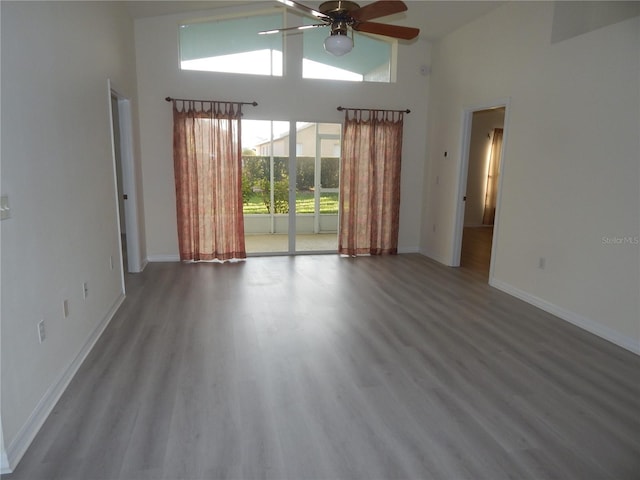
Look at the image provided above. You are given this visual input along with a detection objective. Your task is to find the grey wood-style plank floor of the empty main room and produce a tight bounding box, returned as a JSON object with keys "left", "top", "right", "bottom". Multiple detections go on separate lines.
{"left": 6, "top": 254, "right": 640, "bottom": 480}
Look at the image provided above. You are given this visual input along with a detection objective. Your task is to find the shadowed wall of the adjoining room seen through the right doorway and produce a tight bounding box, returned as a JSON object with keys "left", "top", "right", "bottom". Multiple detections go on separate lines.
{"left": 464, "top": 108, "right": 504, "bottom": 227}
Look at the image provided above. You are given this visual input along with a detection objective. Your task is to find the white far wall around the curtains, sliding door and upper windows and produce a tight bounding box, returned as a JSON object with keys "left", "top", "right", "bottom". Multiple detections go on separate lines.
{"left": 135, "top": 5, "right": 429, "bottom": 260}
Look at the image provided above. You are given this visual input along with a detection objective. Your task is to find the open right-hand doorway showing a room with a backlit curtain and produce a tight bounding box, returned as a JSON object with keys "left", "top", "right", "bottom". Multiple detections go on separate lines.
{"left": 454, "top": 103, "right": 507, "bottom": 281}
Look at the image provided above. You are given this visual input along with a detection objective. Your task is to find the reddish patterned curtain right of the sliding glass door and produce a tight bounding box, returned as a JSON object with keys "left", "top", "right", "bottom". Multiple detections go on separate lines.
{"left": 338, "top": 110, "right": 404, "bottom": 256}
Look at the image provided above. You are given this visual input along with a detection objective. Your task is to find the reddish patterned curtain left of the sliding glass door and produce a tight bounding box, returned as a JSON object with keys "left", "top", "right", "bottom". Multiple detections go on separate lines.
{"left": 173, "top": 100, "right": 247, "bottom": 261}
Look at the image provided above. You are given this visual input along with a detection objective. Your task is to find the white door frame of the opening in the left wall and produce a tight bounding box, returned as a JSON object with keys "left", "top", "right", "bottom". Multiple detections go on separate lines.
{"left": 107, "top": 79, "right": 142, "bottom": 278}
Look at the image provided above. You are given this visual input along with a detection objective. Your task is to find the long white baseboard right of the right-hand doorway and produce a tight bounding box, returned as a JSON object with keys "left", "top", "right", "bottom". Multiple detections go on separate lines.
{"left": 489, "top": 280, "right": 640, "bottom": 355}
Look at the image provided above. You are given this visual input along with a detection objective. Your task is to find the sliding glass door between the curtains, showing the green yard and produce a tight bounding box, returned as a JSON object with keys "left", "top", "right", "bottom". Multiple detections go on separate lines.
{"left": 242, "top": 119, "right": 342, "bottom": 255}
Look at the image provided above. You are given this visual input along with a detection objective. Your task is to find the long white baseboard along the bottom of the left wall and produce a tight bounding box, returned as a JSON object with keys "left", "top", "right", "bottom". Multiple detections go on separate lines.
{"left": 1, "top": 293, "right": 125, "bottom": 474}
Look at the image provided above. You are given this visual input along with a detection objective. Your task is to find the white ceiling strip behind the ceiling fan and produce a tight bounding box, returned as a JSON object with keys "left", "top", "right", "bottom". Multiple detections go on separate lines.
{"left": 125, "top": 0, "right": 504, "bottom": 40}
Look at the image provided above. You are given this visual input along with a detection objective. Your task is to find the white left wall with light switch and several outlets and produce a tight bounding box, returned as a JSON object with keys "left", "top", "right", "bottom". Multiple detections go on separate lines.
{"left": 0, "top": 1, "right": 136, "bottom": 468}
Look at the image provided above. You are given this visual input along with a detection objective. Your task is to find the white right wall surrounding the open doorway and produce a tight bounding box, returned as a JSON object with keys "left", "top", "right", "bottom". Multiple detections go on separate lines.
{"left": 421, "top": 2, "right": 640, "bottom": 353}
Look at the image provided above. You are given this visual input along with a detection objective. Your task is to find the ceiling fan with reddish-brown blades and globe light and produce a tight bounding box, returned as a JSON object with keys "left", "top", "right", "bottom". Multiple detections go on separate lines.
{"left": 260, "top": 0, "right": 420, "bottom": 56}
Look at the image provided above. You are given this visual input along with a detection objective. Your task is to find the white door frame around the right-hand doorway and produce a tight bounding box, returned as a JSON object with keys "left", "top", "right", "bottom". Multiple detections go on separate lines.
{"left": 451, "top": 97, "right": 511, "bottom": 284}
